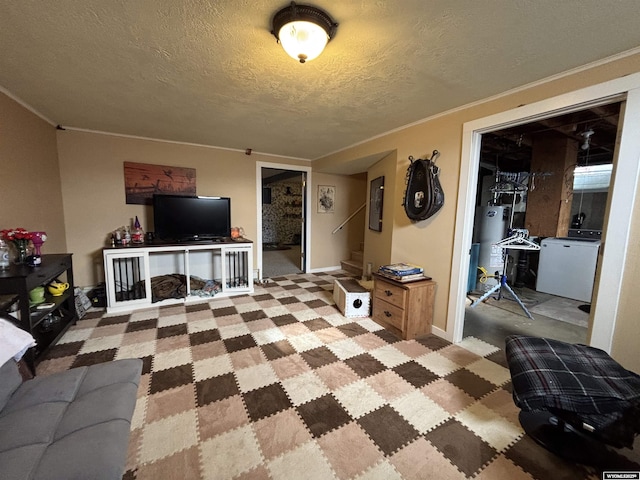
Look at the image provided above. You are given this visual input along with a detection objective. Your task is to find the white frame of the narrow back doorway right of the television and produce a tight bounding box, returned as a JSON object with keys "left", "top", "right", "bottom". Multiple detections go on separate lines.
{"left": 255, "top": 162, "right": 311, "bottom": 280}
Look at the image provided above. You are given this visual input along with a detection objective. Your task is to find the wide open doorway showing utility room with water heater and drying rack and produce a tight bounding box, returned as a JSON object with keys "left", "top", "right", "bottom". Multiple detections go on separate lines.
{"left": 463, "top": 102, "right": 621, "bottom": 345}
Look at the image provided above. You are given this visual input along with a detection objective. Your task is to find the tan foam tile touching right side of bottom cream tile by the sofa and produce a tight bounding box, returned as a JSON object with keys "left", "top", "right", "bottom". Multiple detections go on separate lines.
{"left": 197, "top": 395, "right": 250, "bottom": 441}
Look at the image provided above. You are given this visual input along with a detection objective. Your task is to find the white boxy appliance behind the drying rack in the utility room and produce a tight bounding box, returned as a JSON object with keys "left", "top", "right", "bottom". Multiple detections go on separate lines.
{"left": 536, "top": 237, "right": 600, "bottom": 303}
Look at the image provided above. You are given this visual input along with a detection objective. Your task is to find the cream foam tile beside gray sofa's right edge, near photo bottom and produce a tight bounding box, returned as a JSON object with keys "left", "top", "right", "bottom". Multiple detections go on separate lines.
{"left": 140, "top": 410, "right": 198, "bottom": 463}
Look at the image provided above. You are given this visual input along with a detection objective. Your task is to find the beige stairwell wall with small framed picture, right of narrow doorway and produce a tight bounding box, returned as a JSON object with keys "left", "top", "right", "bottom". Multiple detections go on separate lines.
{"left": 311, "top": 172, "right": 367, "bottom": 270}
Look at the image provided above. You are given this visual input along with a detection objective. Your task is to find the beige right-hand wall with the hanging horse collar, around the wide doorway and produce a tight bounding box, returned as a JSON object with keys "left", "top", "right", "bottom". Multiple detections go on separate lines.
{"left": 314, "top": 55, "right": 640, "bottom": 370}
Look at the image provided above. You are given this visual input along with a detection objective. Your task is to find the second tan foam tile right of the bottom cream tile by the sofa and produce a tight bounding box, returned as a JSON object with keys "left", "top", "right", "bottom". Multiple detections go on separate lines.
{"left": 252, "top": 409, "right": 312, "bottom": 460}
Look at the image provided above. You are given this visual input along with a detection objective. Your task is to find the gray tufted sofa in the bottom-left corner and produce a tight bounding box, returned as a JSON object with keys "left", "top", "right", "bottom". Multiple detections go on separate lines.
{"left": 0, "top": 359, "right": 142, "bottom": 480}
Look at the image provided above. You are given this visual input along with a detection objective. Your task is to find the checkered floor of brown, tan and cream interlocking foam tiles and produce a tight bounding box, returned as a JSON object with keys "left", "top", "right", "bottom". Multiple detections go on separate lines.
{"left": 37, "top": 272, "right": 640, "bottom": 480}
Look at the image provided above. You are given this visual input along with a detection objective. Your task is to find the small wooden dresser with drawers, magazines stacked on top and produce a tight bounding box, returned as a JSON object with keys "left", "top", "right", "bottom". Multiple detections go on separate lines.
{"left": 372, "top": 273, "right": 436, "bottom": 340}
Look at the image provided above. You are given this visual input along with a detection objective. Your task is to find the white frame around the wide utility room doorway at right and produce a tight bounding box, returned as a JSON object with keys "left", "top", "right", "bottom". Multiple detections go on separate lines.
{"left": 445, "top": 73, "right": 640, "bottom": 352}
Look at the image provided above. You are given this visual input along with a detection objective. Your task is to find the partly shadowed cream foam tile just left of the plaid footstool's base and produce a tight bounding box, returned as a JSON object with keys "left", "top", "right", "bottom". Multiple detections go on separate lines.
{"left": 454, "top": 402, "right": 522, "bottom": 452}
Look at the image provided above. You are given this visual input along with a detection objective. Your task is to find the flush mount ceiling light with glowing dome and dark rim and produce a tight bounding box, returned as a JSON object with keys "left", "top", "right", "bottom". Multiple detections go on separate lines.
{"left": 271, "top": 2, "right": 338, "bottom": 63}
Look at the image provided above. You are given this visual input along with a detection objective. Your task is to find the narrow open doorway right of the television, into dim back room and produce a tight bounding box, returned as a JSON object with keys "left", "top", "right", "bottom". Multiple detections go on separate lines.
{"left": 262, "top": 167, "right": 306, "bottom": 278}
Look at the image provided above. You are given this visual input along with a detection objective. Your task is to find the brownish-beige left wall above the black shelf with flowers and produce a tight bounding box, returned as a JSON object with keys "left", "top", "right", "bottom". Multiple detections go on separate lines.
{"left": 0, "top": 93, "right": 67, "bottom": 255}
